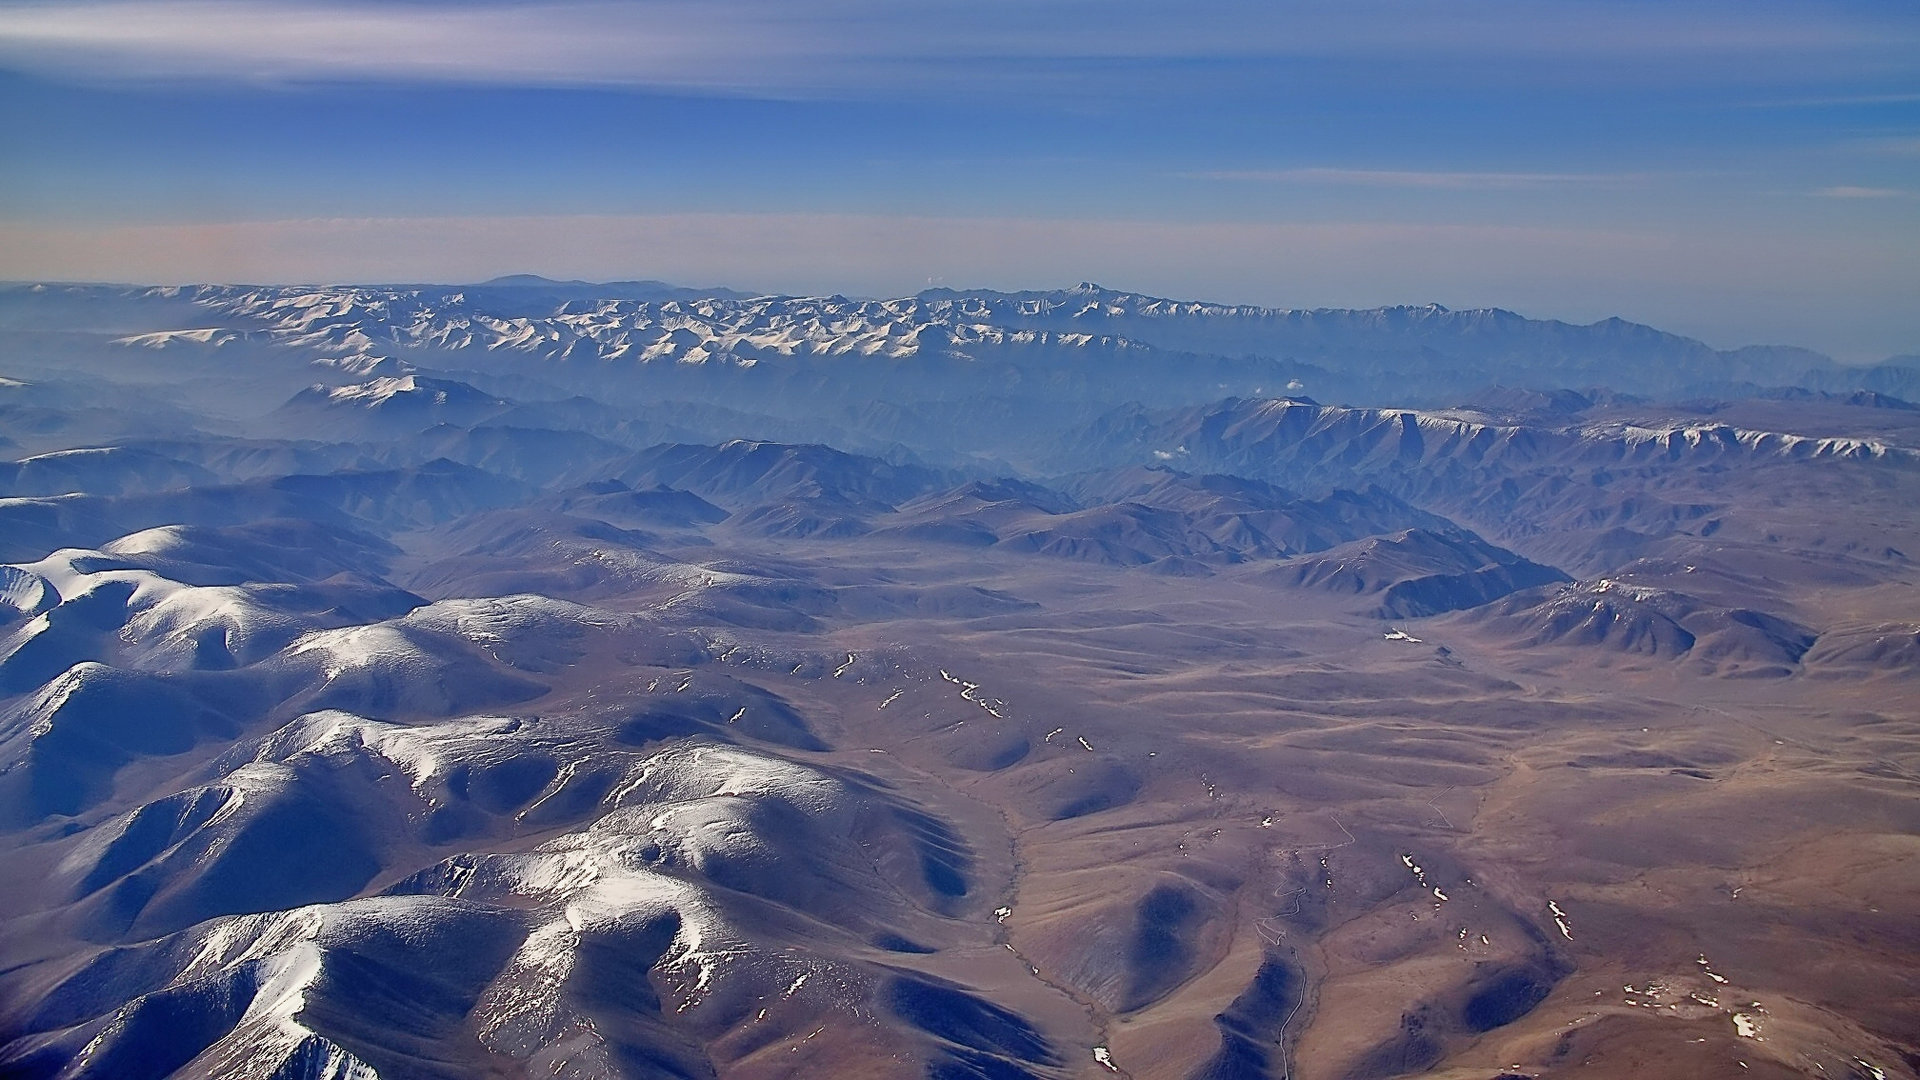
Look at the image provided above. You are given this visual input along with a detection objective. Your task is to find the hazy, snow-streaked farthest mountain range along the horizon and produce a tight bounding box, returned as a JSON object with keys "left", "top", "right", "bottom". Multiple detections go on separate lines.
{"left": 0, "top": 277, "right": 1920, "bottom": 404}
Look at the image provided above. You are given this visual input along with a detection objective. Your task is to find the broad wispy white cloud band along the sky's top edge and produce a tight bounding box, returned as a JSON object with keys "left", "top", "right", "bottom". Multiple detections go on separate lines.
{"left": 0, "top": 0, "right": 1920, "bottom": 94}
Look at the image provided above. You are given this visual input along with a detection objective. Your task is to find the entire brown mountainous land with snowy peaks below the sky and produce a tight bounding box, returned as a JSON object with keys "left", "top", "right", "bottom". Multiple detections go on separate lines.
{"left": 0, "top": 279, "right": 1920, "bottom": 1080}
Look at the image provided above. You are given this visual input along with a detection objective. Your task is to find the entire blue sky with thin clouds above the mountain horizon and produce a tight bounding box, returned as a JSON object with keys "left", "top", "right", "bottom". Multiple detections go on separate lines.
{"left": 0, "top": 0, "right": 1920, "bottom": 359}
